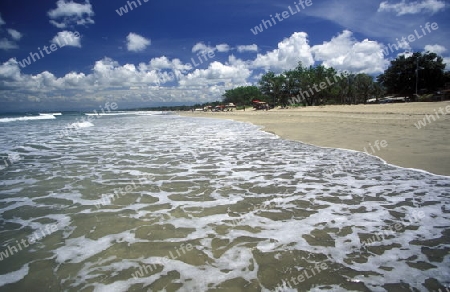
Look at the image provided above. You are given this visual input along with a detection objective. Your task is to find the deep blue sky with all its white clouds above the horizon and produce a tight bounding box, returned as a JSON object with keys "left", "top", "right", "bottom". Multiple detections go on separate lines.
{"left": 0, "top": 0, "right": 450, "bottom": 111}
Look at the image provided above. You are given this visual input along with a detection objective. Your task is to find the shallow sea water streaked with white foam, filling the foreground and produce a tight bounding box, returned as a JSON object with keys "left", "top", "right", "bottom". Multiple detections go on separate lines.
{"left": 0, "top": 112, "right": 450, "bottom": 292}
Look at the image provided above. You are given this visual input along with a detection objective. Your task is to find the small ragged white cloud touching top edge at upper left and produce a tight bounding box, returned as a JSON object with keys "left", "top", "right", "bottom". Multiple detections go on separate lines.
{"left": 47, "top": 0, "right": 95, "bottom": 28}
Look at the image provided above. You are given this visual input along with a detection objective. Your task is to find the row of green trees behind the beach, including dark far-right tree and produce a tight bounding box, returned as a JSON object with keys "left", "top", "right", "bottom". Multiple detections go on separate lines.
{"left": 223, "top": 52, "right": 450, "bottom": 107}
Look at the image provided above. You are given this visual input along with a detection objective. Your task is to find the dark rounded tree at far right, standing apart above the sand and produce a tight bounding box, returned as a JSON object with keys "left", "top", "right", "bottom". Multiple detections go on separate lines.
{"left": 377, "top": 52, "right": 445, "bottom": 96}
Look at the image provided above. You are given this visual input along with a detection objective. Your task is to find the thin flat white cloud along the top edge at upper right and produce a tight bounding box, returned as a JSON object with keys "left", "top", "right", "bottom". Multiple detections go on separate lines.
{"left": 378, "top": 0, "right": 446, "bottom": 16}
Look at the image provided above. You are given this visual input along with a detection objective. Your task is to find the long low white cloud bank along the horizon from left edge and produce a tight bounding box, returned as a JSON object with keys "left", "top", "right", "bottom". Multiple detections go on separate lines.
{"left": 0, "top": 51, "right": 252, "bottom": 105}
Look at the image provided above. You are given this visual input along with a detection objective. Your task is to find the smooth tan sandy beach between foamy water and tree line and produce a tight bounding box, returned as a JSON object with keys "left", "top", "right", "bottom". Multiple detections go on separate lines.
{"left": 179, "top": 102, "right": 450, "bottom": 176}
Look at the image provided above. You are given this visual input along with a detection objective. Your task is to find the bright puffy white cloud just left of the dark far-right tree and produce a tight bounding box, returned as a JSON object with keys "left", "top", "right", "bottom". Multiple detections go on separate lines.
{"left": 311, "top": 30, "right": 388, "bottom": 74}
